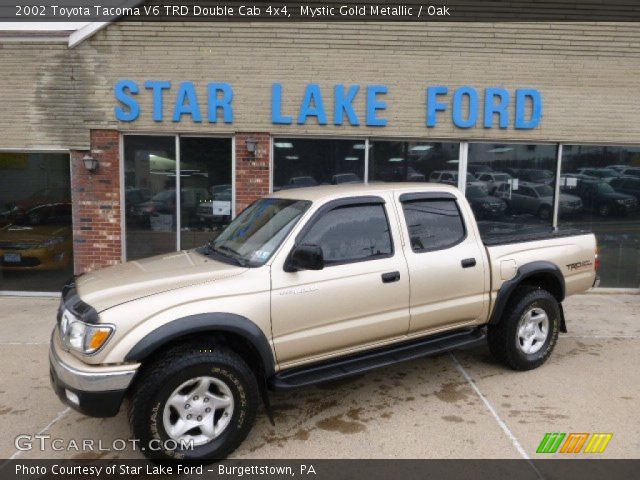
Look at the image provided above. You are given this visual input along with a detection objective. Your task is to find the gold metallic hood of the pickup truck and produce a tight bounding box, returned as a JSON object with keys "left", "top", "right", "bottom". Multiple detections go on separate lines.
{"left": 76, "top": 250, "right": 247, "bottom": 312}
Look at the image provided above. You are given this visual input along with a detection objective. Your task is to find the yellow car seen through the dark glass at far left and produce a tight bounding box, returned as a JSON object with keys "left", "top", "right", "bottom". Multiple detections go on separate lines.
{"left": 0, "top": 203, "right": 73, "bottom": 270}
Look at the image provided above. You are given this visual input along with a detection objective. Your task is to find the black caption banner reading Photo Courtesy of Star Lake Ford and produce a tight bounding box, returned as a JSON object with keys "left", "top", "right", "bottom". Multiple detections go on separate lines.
{"left": 0, "top": 459, "right": 640, "bottom": 480}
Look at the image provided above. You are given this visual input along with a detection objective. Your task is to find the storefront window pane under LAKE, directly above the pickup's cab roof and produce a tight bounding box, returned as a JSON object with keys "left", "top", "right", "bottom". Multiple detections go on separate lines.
{"left": 273, "top": 138, "right": 365, "bottom": 191}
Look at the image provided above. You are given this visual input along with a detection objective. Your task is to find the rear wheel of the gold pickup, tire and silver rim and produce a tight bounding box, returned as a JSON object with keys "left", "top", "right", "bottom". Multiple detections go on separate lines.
{"left": 488, "top": 287, "right": 560, "bottom": 370}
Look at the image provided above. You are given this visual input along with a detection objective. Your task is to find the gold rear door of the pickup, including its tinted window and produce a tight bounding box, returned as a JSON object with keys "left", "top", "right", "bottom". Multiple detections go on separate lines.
{"left": 398, "top": 192, "right": 489, "bottom": 335}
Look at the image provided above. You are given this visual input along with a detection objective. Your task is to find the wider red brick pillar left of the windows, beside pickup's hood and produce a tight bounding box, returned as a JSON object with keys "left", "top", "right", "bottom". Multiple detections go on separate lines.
{"left": 71, "top": 130, "right": 122, "bottom": 274}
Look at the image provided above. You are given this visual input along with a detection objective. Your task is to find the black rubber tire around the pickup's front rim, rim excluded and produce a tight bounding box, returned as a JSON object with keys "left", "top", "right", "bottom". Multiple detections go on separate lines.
{"left": 129, "top": 345, "right": 260, "bottom": 462}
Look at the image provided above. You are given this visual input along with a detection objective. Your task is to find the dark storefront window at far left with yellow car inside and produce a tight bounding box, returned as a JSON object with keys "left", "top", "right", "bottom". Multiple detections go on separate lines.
{"left": 0, "top": 152, "right": 73, "bottom": 292}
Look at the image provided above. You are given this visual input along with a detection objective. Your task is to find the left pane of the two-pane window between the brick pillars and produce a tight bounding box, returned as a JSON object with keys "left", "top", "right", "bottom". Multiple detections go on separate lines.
{"left": 124, "top": 135, "right": 177, "bottom": 260}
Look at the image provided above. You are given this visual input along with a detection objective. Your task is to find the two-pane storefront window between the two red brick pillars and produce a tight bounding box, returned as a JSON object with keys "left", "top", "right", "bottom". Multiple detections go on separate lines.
{"left": 124, "top": 135, "right": 232, "bottom": 260}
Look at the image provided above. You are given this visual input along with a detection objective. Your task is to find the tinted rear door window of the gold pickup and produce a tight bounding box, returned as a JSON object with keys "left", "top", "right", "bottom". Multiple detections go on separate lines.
{"left": 402, "top": 199, "right": 466, "bottom": 253}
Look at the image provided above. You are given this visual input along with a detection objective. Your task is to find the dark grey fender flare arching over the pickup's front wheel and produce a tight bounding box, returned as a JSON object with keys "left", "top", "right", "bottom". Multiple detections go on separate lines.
{"left": 125, "top": 312, "right": 275, "bottom": 376}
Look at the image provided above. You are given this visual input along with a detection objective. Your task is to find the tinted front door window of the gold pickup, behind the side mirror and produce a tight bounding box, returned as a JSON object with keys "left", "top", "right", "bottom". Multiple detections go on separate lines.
{"left": 302, "top": 205, "right": 393, "bottom": 265}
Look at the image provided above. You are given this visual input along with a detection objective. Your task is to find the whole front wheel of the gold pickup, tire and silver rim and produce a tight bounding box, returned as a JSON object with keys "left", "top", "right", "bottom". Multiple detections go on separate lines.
{"left": 129, "top": 346, "right": 259, "bottom": 461}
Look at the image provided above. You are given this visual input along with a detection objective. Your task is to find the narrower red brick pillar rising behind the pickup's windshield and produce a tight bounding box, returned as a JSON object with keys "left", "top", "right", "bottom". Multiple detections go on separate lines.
{"left": 236, "top": 132, "right": 270, "bottom": 214}
